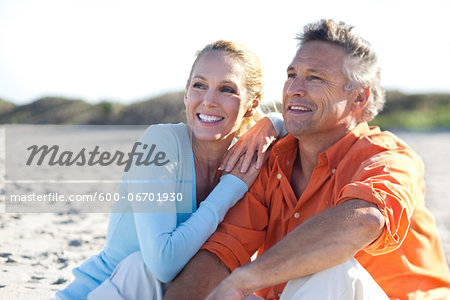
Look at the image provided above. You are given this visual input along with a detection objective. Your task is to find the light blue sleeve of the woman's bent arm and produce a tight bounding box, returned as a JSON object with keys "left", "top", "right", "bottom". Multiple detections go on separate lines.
{"left": 128, "top": 127, "right": 247, "bottom": 282}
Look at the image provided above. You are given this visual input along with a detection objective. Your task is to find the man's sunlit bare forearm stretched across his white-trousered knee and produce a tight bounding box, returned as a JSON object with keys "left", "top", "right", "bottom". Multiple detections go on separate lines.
{"left": 208, "top": 200, "right": 385, "bottom": 299}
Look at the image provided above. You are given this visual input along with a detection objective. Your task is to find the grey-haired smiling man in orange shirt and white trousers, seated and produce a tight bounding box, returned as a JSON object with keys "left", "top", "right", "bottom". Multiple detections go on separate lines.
{"left": 166, "top": 20, "right": 450, "bottom": 299}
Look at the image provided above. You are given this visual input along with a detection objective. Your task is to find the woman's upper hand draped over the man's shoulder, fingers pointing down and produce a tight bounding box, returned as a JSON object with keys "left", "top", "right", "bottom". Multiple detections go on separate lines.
{"left": 220, "top": 118, "right": 277, "bottom": 173}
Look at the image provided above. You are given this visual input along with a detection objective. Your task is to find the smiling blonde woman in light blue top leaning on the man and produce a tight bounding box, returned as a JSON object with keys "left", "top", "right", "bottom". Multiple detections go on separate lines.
{"left": 57, "top": 41, "right": 281, "bottom": 299}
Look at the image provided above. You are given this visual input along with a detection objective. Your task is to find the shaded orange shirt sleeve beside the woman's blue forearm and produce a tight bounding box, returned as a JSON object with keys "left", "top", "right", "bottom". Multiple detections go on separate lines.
{"left": 201, "top": 164, "right": 269, "bottom": 271}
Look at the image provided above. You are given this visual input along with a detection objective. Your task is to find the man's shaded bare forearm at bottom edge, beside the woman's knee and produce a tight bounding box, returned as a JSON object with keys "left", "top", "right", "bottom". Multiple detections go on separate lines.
{"left": 164, "top": 250, "right": 230, "bottom": 300}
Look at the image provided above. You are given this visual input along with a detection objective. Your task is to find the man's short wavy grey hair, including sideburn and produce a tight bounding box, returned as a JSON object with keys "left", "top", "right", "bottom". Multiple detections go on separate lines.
{"left": 297, "top": 19, "right": 385, "bottom": 122}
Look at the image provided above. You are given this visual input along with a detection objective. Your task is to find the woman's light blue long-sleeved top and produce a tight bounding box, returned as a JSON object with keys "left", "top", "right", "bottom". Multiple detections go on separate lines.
{"left": 56, "top": 123, "right": 247, "bottom": 300}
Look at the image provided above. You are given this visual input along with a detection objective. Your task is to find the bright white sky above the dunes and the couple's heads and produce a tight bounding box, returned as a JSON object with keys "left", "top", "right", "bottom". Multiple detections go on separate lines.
{"left": 0, "top": 0, "right": 450, "bottom": 104}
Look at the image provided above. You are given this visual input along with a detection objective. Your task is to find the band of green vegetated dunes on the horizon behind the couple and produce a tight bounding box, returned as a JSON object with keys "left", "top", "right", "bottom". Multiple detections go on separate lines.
{"left": 0, "top": 91, "right": 450, "bottom": 130}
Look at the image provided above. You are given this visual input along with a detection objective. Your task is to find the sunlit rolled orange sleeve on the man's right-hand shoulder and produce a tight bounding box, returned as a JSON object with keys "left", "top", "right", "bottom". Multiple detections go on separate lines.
{"left": 336, "top": 148, "right": 425, "bottom": 255}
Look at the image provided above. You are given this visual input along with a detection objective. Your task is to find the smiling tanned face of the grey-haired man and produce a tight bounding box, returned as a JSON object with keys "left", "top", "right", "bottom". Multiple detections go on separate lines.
{"left": 283, "top": 41, "right": 354, "bottom": 138}
